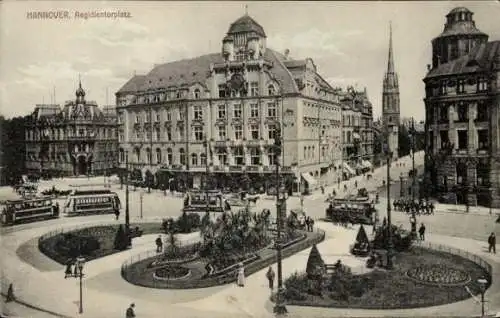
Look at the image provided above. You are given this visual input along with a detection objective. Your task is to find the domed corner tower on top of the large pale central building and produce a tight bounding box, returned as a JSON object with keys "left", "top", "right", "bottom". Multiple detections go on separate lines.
{"left": 222, "top": 14, "right": 267, "bottom": 61}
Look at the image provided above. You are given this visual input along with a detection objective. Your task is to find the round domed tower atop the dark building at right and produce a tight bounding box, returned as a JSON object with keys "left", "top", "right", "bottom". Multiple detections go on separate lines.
{"left": 432, "top": 7, "right": 488, "bottom": 68}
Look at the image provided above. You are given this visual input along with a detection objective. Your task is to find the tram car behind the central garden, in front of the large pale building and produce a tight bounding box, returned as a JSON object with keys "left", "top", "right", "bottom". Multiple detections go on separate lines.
{"left": 182, "top": 190, "right": 227, "bottom": 212}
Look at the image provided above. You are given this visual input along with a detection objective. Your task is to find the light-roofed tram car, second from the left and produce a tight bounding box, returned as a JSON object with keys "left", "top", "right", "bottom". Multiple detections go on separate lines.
{"left": 63, "top": 190, "right": 121, "bottom": 216}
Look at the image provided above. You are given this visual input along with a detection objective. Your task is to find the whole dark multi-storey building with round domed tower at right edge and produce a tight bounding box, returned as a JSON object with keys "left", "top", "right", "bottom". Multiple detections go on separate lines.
{"left": 424, "top": 7, "right": 500, "bottom": 207}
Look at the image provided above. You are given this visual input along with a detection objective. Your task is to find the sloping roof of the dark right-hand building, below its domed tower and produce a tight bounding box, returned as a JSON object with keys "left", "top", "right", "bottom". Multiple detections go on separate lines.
{"left": 424, "top": 41, "right": 500, "bottom": 81}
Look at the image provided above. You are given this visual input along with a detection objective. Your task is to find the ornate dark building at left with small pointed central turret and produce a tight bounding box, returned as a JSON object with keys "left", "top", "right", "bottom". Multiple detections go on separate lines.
{"left": 25, "top": 82, "right": 118, "bottom": 176}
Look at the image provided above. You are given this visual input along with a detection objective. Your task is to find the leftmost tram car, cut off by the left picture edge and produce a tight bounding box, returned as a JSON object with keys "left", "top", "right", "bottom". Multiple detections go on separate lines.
{"left": 1, "top": 197, "right": 59, "bottom": 225}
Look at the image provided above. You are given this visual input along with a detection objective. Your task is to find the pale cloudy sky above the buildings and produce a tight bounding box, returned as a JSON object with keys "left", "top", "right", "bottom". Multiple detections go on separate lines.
{"left": 0, "top": 0, "right": 500, "bottom": 120}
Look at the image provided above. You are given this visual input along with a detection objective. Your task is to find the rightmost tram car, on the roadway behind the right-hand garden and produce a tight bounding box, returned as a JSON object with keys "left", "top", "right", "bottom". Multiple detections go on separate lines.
{"left": 326, "top": 198, "right": 377, "bottom": 225}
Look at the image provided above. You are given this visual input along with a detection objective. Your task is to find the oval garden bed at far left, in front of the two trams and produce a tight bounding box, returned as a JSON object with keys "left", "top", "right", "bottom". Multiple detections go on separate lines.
{"left": 38, "top": 223, "right": 163, "bottom": 265}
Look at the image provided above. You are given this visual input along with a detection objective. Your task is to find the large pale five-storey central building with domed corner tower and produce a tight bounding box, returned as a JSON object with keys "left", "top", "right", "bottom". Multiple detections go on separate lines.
{"left": 116, "top": 15, "right": 342, "bottom": 193}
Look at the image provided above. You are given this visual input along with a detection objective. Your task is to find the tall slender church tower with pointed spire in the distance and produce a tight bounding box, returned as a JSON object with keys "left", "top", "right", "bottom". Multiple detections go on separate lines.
{"left": 382, "top": 26, "right": 400, "bottom": 160}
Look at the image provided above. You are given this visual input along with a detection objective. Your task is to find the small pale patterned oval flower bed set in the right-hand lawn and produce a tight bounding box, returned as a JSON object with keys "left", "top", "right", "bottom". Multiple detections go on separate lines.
{"left": 406, "top": 264, "right": 470, "bottom": 286}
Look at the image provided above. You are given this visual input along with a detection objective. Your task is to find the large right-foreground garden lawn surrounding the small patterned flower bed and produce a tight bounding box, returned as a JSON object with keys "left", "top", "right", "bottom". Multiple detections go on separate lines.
{"left": 285, "top": 247, "right": 488, "bottom": 309}
